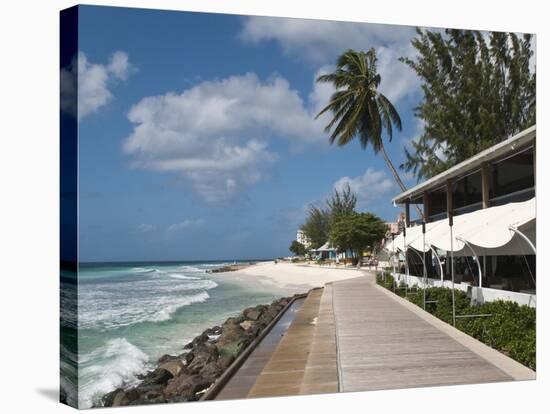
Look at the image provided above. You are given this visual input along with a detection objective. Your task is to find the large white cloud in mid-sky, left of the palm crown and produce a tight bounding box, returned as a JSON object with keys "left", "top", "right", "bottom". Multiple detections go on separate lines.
{"left": 123, "top": 73, "right": 330, "bottom": 202}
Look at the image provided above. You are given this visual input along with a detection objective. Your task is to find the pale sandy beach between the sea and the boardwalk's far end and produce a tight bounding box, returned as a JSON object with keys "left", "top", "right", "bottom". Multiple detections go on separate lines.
{"left": 220, "top": 262, "right": 366, "bottom": 293}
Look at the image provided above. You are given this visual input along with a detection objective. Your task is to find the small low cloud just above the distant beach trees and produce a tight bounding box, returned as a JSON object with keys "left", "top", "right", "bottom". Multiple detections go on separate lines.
{"left": 334, "top": 168, "right": 396, "bottom": 209}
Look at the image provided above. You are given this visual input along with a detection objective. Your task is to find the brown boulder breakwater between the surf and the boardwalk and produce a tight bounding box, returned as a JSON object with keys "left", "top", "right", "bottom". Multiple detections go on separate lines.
{"left": 101, "top": 298, "right": 304, "bottom": 407}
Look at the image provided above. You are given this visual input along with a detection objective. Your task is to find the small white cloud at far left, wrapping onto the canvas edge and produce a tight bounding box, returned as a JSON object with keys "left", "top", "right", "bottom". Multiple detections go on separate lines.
{"left": 61, "top": 51, "right": 135, "bottom": 120}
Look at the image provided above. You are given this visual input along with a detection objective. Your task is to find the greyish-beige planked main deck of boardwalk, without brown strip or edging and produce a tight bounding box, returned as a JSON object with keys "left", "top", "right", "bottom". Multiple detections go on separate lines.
{"left": 333, "top": 277, "right": 513, "bottom": 392}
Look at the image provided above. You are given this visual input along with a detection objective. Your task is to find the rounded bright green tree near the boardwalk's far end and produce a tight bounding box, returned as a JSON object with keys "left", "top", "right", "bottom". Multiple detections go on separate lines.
{"left": 330, "top": 212, "right": 386, "bottom": 264}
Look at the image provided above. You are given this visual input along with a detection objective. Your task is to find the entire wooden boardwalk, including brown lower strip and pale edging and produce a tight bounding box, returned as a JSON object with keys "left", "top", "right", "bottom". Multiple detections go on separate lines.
{"left": 216, "top": 274, "right": 535, "bottom": 399}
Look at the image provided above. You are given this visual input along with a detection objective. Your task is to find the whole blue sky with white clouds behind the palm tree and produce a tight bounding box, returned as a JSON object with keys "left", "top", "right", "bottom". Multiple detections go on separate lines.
{"left": 72, "top": 6, "right": 432, "bottom": 262}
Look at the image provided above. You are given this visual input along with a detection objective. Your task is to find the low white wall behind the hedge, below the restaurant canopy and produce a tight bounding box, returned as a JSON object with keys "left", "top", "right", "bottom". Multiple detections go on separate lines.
{"left": 394, "top": 273, "right": 537, "bottom": 308}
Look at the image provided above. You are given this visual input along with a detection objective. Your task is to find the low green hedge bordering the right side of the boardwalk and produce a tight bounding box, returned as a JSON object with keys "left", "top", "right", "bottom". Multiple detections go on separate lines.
{"left": 377, "top": 275, "right": 536, "bottom": 370}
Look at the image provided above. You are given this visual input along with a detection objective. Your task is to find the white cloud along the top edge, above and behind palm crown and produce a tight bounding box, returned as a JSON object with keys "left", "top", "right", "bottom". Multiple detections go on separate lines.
{"left": 239, "top": 16, "right": 420, "bottom": 101}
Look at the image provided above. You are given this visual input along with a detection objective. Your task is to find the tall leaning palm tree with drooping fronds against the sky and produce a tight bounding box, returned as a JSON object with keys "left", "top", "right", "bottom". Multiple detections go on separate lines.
{"left": 315, "top": 49, "right": 423, "bottom": 216}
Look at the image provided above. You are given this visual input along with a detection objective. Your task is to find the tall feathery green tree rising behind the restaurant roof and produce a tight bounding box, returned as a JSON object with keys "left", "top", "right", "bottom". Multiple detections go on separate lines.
{"left": 400, "top": 29, "right": 536, "bottom": 179}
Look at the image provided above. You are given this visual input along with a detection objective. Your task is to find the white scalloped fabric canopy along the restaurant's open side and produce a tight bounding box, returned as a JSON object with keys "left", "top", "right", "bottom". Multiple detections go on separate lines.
{"left": 386, "top": 198, "right": 536, "bottom": 256}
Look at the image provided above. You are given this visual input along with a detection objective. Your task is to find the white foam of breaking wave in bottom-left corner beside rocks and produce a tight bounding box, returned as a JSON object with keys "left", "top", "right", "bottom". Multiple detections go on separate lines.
{"left": 79, "top": 338, "right": 149, "bottom": 408}
